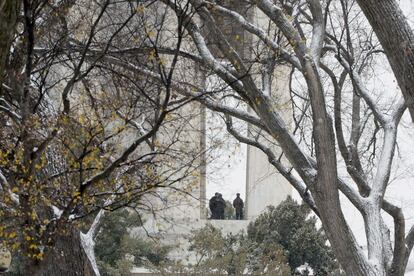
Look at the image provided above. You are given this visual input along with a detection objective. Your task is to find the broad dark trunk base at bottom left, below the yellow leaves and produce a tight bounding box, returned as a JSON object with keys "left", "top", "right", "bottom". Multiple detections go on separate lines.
{"left": 24, "top": 227, "right": 95, "bottom": 276}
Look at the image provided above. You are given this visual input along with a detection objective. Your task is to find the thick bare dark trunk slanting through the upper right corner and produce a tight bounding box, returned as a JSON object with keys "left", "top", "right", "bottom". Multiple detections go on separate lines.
{"left": 357, "top": 0, "right": 414, "bottom": 120}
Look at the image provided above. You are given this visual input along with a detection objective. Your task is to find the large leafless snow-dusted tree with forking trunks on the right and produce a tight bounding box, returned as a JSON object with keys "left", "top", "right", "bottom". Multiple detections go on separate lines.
{"left": 112, "top": 0, "right": 413, "bottom": 275}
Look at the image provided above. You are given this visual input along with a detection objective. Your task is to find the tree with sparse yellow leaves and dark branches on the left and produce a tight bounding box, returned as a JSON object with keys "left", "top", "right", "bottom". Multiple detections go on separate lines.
{"left": 0, "top": 0, "right": 205, "bottom": 275}
